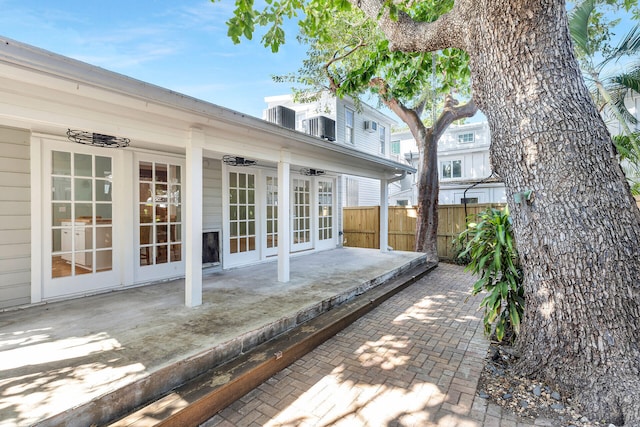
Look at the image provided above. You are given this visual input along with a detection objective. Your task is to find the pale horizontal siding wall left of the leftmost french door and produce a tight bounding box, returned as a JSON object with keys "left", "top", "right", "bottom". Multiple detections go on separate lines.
{"left": 0, "top": 127, "right": 31, "bottom": 308}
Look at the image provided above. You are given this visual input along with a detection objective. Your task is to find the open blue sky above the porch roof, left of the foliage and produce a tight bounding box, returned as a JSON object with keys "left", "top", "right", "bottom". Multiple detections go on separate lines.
{"left": 0, "top": 0, "right": 306, "bottom": 117}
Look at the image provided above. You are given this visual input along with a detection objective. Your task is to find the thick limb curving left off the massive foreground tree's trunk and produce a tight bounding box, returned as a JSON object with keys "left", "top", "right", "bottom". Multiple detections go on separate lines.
{"left": 349, "top": 0, "right": 467, "bottom": 52}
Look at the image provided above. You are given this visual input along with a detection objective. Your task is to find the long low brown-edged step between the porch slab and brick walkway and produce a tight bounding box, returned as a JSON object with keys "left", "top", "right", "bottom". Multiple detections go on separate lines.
{"left": 110, "top": 264, "right": 436, "bottom": 427}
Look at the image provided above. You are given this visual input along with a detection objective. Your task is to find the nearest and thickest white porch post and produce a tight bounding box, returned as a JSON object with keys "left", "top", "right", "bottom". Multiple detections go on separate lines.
{"left": 183, "top": 129, "right": 204, "bottom": 307}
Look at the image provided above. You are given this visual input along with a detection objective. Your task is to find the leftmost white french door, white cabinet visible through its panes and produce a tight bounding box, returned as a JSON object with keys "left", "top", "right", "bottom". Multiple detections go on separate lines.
{"left": 42, "top": 142, "right": 119, "bottom": 299}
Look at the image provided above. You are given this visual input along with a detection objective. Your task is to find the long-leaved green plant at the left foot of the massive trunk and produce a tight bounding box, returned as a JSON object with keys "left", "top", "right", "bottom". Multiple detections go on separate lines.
{"left": 456, "top": 208, "right": 525, "bottom": 343}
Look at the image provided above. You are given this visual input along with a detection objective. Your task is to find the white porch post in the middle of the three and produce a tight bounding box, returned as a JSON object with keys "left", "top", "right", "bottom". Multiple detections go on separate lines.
{"left": 278, "top": 153, "right": 291, "bottom": 283}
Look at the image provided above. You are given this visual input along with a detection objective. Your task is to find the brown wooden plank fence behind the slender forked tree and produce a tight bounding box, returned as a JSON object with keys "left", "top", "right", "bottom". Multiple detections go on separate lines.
{"left": 342, "top": 203, "right": 505, "bottom": 259}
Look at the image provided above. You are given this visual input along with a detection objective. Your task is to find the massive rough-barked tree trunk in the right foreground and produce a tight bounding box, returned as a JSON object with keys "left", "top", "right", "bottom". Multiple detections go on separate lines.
{"left": 360, "top": 0, "right": 640, "bottom": 425}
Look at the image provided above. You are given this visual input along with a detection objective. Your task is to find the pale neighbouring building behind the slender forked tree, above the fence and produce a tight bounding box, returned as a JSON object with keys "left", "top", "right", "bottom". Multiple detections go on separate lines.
{"left": 389, "top": 122, "right": 506, "bottom": 205}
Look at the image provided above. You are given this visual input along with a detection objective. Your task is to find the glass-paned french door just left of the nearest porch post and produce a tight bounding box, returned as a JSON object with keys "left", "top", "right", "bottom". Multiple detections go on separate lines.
{"left": 135, "top": 155, "right": 185, "bottom": 283}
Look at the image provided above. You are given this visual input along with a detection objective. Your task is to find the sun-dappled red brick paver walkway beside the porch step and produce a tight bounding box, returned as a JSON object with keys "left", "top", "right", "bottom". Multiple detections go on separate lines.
{"left": 205, "top": 263, "right": 533, "bottom": 427}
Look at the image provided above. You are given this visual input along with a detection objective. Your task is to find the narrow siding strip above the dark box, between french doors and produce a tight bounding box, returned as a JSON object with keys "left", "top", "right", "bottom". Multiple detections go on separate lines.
{"left": 202, "top": 159, "right": 222, "bottom": 232}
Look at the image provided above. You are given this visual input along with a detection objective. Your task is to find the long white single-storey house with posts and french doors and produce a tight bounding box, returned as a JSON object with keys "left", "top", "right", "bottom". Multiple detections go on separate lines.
{"left": 0, "top": 38, "right": 414, "bottom": 308}
